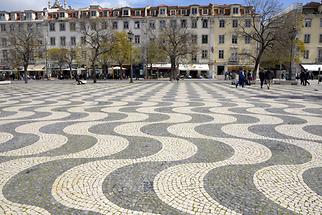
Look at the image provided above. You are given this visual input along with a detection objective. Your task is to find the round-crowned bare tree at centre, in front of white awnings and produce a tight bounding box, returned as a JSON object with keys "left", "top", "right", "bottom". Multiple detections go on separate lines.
{"left": 156, "top": 25, "right": 198, "bottom": 81}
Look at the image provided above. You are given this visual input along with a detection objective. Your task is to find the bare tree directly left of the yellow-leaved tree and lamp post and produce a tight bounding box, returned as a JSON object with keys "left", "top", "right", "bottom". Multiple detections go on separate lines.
{"left": 81, "top": 19, "right": 113, "bottom": 83}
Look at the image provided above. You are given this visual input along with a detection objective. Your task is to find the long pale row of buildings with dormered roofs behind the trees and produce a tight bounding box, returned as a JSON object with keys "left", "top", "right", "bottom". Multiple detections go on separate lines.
{"left": 0, "top": 0, "right": 256, "bottom": 78}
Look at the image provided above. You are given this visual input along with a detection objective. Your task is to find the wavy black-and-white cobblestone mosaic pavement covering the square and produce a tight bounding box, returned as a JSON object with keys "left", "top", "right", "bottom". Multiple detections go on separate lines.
{"left": 0, "top": 81, "right": 322, "bottom": 214}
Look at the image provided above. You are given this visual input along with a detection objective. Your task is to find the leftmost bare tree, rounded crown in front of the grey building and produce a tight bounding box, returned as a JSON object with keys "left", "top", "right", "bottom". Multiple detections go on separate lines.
{"left": 8, "top": 23, "right": 43, "bottom": 83}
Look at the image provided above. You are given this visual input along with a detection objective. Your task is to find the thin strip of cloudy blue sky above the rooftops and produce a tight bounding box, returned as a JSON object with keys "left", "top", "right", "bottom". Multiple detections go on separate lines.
{"left": 0, "top": 0, "right": 316, "bottom": 11}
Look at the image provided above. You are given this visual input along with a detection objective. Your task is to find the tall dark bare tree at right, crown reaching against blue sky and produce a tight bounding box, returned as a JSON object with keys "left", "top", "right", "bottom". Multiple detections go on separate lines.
{"left": 239, "top": 0, "right": 283, "bottom": 77}
